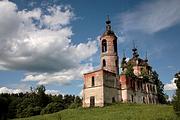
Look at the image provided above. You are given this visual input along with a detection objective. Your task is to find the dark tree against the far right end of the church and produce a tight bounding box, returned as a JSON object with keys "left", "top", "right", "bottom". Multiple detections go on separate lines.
{"left": 152, "top": 71, "right": 167, "bottom": 104}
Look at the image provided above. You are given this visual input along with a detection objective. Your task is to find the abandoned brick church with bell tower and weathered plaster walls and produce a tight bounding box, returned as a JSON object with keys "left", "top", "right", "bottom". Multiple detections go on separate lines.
{"left": 82, "top": 18, "right": 158, "bottom": 107}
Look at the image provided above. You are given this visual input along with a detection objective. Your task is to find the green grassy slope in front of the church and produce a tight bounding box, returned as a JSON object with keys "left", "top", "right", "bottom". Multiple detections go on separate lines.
{"left": 16, "top": 104, "right": 180, "bottom": 120}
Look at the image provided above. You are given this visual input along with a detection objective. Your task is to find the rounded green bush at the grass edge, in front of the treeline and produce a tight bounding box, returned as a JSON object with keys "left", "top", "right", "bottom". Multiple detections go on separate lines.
{"left": 41, "top": 102, "right": 64, "bottom": 115}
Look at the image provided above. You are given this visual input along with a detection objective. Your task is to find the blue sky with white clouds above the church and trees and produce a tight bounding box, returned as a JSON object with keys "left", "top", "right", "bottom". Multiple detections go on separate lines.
{"left": 0, "top": 0, "right": 180, "bottom": 97}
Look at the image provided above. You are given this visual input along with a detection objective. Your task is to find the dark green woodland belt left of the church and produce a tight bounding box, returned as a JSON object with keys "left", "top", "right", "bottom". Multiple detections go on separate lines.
{"left": 0, "top": 85, "right": 81, "bottom": 120}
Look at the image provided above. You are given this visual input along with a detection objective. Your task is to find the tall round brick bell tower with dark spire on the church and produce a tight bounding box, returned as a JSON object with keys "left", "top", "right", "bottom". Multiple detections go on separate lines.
{"left": 100, "top": 16, "right": 119, "bottom": 75}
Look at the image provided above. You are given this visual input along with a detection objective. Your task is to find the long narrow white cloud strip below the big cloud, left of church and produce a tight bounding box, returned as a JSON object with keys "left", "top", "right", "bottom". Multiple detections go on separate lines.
{"left": 22, "top": 64, "right": 93, "bottom": 85}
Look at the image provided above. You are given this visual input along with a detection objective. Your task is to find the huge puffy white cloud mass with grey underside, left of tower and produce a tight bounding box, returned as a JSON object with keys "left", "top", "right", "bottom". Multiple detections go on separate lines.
{"left": 0, "top": 1, "right": 97, "bottom": 84}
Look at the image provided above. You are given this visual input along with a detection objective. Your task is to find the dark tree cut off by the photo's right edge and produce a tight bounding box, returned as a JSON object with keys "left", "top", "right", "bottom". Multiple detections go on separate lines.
{"left": 173, "top": 72, "right": 180, "bottom": 117}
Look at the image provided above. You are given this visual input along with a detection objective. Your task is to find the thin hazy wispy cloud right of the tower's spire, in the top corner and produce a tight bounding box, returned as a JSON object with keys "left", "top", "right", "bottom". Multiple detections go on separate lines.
{"left": 120, "top": 0, "right": 180, "bottom": 34}
